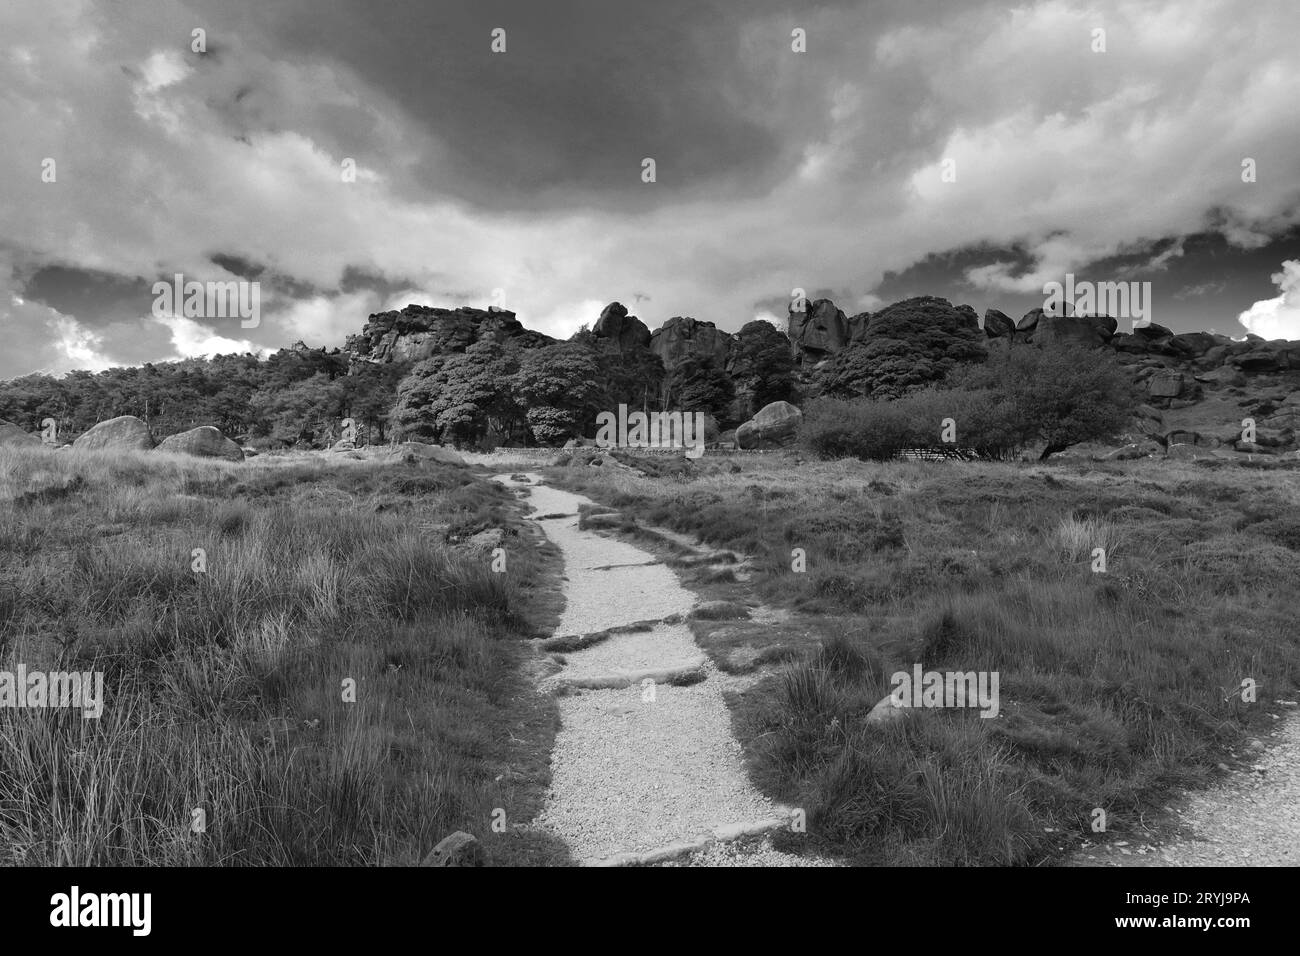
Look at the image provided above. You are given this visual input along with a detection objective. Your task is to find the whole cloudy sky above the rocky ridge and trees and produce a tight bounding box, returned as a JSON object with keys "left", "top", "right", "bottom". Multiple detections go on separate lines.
{"left": 0, "top": 0, "right": 1300, "bottom": 377}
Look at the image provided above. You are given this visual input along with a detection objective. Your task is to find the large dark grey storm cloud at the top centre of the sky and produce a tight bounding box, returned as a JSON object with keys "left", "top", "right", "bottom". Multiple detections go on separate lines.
{"left": 199, "top": 0, "right": 924, "bottom": 209}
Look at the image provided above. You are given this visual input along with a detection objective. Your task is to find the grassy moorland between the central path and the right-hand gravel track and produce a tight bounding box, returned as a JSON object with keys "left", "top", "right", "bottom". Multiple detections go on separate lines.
{"left": 546, "top": 453, "right": 1300, "bottom": 865}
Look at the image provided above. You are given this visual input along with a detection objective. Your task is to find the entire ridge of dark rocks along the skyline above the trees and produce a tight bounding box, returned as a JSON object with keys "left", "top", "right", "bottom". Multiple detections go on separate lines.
{"left": 345, "top": 297, "right": 1300, "bottom": 458}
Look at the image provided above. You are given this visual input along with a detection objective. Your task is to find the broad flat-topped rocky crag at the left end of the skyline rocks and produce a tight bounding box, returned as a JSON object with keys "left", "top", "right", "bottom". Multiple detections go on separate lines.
{"left": 343, "top": 306, "right": 555, "bottom": 363}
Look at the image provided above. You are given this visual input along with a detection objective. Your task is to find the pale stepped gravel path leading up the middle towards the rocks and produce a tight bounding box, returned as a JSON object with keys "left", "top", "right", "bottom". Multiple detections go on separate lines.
{"left": 495, "top": 475, "right": 824, "bottom": 866}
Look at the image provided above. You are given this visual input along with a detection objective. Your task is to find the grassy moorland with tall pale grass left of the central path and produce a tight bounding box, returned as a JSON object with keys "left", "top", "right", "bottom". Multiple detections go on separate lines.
{"left": 0, "top": 449, "right": 566, "bottom": 865}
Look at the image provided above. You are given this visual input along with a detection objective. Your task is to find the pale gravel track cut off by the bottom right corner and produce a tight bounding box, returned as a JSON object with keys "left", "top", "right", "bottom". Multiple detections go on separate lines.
{"left": 1073, "top": 709, "right": 1300, "bottom": 866}
